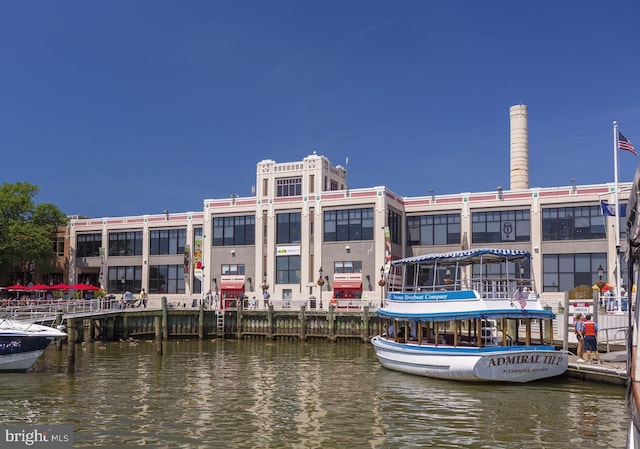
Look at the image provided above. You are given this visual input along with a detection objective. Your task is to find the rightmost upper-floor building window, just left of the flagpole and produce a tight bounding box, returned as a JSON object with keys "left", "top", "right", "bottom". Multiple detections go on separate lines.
{"left": 542, "top": 206, "right": 606, "bottom": 241}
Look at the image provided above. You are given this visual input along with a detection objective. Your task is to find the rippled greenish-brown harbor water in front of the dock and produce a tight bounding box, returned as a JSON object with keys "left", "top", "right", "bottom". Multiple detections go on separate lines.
{"left": 0, "top": 340, "right": 628, "bottom": 449}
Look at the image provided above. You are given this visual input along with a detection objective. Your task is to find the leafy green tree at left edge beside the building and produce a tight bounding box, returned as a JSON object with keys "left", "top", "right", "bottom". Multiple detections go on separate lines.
{"left": 0, "top": 182, "right": 67, "bottom": 284}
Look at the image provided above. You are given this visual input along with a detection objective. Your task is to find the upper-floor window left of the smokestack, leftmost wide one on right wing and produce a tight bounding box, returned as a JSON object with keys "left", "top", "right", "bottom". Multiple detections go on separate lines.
{"left": 407, "top": 214, "right": 460, "bottom": 246}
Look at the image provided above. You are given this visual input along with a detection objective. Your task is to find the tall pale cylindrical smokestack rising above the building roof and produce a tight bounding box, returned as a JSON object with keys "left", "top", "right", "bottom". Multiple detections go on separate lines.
{"left": 509, "top": 104, "right": 529, "bottom": 190}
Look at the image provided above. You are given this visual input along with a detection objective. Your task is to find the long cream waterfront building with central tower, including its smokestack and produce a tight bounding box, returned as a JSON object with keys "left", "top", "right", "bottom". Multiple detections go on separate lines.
{"left": 67, "top": 105, "right": 630, "bottom": 308}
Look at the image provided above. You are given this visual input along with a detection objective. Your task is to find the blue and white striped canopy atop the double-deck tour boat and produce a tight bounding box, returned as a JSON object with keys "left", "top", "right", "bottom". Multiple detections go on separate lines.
{"left": 391, "top": 248, "right": 531, "bottom": 267}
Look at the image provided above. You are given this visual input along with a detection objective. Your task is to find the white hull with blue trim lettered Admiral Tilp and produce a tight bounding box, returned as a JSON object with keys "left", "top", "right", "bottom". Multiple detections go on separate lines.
{"left": 371, "top": 336, "right": 569, "bottom": 382}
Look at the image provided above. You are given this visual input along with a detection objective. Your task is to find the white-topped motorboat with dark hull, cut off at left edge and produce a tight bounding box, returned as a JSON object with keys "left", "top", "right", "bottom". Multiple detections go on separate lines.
{"left": 0, "top": 319, "right": 67, "bottom": 371}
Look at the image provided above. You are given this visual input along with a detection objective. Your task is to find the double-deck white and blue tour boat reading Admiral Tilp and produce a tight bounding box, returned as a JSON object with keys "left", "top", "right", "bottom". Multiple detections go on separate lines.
{"left": 372, "top": 248, "right": 569, "bottom": 382}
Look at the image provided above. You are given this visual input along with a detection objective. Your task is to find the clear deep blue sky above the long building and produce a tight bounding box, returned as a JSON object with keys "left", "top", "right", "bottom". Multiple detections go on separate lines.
{"left": 0, "top": 0, "right": 640, "bottom": 217}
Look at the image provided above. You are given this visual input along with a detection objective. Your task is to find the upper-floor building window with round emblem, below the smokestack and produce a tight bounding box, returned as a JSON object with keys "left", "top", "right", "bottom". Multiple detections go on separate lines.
{"left": 471, "top": 210, "right": 531, "bottom": 244}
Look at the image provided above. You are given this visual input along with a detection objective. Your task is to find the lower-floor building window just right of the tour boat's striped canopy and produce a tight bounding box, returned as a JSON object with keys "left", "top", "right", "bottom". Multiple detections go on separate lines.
{"left": 542, "top": 253, "right": 608, "bottom": 292}
